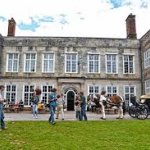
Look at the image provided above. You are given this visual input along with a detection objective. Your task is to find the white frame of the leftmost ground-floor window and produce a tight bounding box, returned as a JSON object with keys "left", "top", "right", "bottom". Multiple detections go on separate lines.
{"left": 4, "top": 84, "right": 17, "bottom": 103}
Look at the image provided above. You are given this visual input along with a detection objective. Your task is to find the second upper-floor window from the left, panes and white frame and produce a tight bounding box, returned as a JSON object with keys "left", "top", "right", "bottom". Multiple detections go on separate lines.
{"left": 25, "top": 53, "right": 36, "bottom": 72}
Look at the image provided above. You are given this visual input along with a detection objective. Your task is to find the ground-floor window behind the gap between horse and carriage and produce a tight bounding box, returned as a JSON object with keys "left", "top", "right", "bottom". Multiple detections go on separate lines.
{"left": 124, "top": 85, "right": 136, "bottom": 106}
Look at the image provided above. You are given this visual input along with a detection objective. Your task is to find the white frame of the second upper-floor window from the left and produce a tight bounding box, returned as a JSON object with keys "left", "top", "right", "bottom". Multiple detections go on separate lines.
{"left": 24, "top": 53, "right": 37, "bottom": 73}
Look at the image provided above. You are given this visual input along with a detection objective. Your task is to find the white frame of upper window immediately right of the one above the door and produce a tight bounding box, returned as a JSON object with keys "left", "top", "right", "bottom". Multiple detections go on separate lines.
{"left": 87, "top": 53, "right": 100, "bottom": 73}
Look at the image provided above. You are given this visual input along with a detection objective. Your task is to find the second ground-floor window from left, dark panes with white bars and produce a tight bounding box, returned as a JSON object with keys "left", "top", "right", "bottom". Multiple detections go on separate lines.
{"left": 24, "top": 85, "right": 34, "bottom": 106}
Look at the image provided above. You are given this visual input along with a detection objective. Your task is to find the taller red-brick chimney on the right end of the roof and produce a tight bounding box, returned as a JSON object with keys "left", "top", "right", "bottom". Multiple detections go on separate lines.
{"left": 126, "top": 13, "right": 137, "bottom": 39}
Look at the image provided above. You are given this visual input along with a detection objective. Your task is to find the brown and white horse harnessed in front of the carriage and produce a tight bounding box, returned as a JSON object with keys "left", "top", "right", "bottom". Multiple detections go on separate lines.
{"left": 94, "top": 94, "right": 125, "bottom": 119}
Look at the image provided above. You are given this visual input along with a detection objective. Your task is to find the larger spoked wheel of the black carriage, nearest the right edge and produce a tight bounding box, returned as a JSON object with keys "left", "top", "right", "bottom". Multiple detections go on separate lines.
{"left": 137, "top": 105, "right": 148, "bottom": 120}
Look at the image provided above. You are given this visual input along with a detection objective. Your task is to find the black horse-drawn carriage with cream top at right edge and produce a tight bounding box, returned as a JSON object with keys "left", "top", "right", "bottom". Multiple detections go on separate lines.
{"left": 129, "top": 95, "right": 150, "bottom": 120}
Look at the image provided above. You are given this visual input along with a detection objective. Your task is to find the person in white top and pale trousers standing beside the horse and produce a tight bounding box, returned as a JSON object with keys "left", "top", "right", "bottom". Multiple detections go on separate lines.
{"left": 99, "top": 91, "right": 106, "bottom": 120}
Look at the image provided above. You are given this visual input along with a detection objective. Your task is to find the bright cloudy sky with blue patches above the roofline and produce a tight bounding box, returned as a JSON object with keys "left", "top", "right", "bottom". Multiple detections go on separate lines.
{"left": 0, "top": 0, "right": 150, "bottom": 38}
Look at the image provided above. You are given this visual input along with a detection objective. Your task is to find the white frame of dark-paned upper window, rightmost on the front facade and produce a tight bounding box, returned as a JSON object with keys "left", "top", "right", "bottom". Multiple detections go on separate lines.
{"left": 123, "top": 54, "right": 135, "bottom": 74}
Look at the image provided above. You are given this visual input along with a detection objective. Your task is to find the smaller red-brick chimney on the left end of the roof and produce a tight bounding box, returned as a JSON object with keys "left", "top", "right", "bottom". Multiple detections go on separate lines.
{"left": 7, "top": 18, "right": 16, "bottom": 36}
